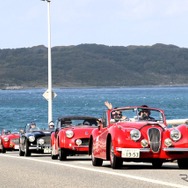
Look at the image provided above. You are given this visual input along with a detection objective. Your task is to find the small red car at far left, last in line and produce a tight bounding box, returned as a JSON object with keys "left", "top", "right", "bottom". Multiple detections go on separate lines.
{"left": 0, "top": 129, "right": 20, "bottom": 153}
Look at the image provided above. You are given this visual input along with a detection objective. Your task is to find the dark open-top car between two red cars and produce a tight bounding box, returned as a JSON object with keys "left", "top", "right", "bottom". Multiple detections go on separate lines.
{"left": 19, "top": 122, "right": 53, "bottom": 156}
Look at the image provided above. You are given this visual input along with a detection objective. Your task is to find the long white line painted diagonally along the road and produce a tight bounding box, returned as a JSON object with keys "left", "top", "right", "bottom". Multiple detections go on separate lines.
{"left": 0, "top": 155, "right": 187, "bottom": 188}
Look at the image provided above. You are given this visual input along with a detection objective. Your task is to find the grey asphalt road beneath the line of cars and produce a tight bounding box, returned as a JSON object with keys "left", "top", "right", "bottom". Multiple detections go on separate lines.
{"left": 0, "top": 152, "right": 188, "bottom": 188}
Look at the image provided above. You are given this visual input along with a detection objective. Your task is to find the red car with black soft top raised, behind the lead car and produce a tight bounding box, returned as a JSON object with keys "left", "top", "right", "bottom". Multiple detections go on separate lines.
{"left": 51, "top": 116, "right": 98, "bottom": 161}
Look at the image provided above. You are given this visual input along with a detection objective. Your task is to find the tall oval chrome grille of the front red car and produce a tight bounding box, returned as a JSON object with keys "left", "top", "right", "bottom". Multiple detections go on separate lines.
{"left": 148, "top": 128, "right": 161, "bottom": 153}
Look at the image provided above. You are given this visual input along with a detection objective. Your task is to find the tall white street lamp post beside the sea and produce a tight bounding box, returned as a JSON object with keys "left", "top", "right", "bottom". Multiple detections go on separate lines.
{"left": 42, "top": 0, "right": 53, "bottom": 123}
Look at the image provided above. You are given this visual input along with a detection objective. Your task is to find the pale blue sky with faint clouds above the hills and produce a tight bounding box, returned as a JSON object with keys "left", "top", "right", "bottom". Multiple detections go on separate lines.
{"left": 0, "top": 0, "right": 188, "bottom": 49}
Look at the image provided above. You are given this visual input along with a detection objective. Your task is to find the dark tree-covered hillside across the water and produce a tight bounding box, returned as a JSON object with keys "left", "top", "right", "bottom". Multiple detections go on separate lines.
{"left": 0, "top": 44, "right": 188, "bottom": 88}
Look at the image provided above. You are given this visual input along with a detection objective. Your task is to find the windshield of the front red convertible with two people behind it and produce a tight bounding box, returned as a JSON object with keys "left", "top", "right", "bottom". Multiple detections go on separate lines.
{"left": 111, "top": 107, "right": 164, "bottom": 123}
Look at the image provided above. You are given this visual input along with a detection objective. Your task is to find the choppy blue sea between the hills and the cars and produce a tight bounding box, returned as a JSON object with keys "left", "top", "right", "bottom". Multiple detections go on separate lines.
{"left": 0, "top": 87, "right": 188, "bottom": 129}
